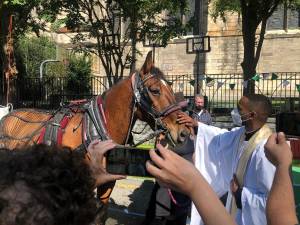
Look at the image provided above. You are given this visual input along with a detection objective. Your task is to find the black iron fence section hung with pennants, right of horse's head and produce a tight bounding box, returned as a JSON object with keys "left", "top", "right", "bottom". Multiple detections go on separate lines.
{"left": 167, "top": 72, "right": 300, "bottom": 113}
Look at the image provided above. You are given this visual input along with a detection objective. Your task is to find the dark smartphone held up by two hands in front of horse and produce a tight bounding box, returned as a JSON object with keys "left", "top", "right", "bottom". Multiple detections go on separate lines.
{"left": 106, "top": 148, "right": 152, "bottom": 177}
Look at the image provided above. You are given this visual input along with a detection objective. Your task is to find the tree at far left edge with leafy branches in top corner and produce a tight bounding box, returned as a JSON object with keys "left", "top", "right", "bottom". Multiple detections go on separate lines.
{"left": 0, "top": 0, "right": 61, "bottom": 104}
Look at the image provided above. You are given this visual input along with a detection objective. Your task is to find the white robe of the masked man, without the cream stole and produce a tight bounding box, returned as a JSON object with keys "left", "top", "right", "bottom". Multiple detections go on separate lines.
{"left": 190, "top": 123, "right": 275, "bottom": 225}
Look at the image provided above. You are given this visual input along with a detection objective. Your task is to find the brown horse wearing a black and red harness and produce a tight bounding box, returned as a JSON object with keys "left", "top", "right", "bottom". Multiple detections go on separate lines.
{"left": 0, "top": 52, "right": 189, "bottom": 220}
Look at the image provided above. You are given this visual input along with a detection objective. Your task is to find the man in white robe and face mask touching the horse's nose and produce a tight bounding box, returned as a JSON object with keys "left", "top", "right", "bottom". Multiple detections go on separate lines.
{"left": 178, "top": 94, "right": 275, "bottom": 225}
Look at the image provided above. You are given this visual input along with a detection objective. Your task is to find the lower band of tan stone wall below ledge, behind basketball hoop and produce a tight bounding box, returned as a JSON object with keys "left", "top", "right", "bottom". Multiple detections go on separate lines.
{"left": 86, "top": 32, "right": 300, "bottom": 75}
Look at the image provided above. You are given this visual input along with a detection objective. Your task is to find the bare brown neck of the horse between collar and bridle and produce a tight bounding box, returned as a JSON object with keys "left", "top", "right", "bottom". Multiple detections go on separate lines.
{"left": 104, "top": 79, "right": 133, "bottom": 144}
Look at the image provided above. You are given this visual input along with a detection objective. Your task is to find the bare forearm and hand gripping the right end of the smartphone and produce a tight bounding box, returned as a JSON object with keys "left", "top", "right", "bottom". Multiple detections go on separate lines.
{"left": 146, "top": 145, "right": 235, "bottom": 225}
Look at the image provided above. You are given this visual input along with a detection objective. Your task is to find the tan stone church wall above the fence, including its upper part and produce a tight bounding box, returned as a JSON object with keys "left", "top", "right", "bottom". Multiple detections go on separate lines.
{"left": 53, "top": 3, "right": 300, "bottom": 75}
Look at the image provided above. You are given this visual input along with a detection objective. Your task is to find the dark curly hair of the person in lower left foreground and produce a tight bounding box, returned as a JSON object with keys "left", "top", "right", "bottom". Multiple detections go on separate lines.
{"left": 0, "top": 145, "right": 97, "bottom": 225}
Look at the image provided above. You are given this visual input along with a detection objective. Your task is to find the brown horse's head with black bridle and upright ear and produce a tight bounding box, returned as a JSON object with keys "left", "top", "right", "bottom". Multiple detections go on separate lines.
{"left": 132, "top": 52, "right": 190, "bottom": 145}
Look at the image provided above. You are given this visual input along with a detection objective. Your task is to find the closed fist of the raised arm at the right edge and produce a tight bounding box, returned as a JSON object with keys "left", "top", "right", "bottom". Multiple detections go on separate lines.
{"left": 265, "top": 132, "right": 293, "bottom": 167}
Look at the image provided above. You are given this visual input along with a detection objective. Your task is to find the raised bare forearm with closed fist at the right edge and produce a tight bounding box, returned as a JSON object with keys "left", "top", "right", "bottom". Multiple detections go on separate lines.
{"left": 265, "top": 133, "right": 298, "bottom": 225}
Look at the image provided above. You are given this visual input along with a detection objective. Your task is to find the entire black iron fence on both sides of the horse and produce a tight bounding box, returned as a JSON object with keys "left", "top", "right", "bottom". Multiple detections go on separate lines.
{"left": 4, "top": 72, "right": 300, "bottom": 113}
